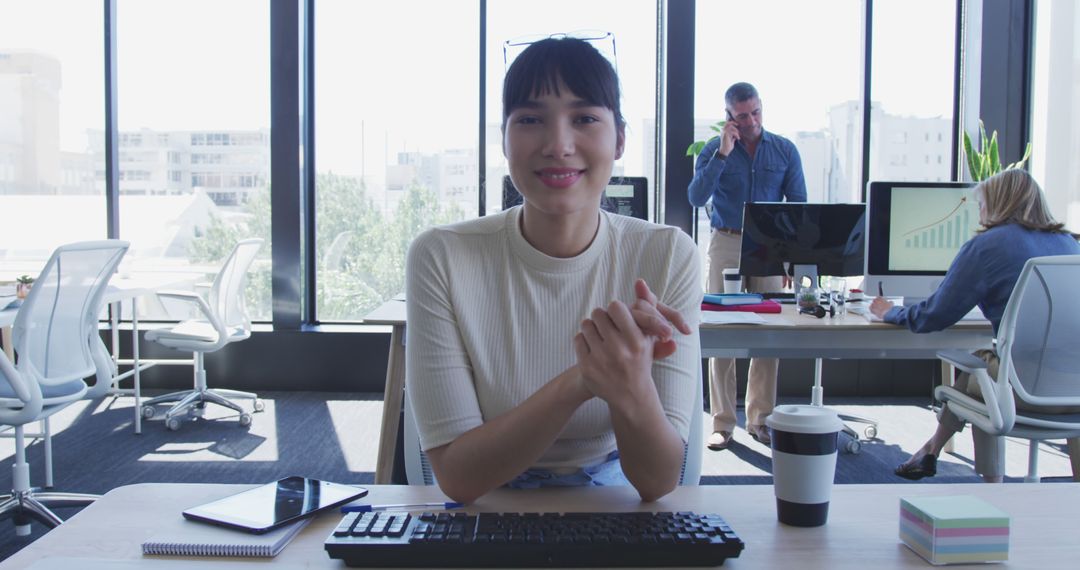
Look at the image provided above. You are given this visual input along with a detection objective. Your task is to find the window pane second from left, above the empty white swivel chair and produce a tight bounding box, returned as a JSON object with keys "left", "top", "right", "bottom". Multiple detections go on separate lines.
{"left": 115, "top": 0, "right": 270, "bottom": 320}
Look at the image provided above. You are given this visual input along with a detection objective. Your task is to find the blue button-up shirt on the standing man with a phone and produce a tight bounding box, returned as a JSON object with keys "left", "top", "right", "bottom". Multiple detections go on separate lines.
{"left": 688, "top": 130, "right": 807, "bottom": 230}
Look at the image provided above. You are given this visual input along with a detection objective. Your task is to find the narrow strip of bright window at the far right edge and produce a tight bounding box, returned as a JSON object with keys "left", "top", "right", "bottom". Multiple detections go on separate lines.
{"left": 1031, "top": 0, "right": 1080, "bottom": 231}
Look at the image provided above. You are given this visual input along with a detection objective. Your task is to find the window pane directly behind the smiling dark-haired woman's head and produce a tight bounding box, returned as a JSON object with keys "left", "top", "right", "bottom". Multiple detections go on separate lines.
{"left": 485, "top": 0, "right": 657, "bottom": 213}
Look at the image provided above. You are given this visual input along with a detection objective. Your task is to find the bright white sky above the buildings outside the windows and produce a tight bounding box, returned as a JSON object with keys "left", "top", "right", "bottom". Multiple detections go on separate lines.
{"left": 0, "top": 0, "right": 955, "bottom": 176}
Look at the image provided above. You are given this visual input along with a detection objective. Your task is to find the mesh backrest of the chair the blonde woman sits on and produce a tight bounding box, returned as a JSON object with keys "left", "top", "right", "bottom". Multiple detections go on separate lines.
{"left": 998, "top": 256, "right": 1080, "bottom": 406}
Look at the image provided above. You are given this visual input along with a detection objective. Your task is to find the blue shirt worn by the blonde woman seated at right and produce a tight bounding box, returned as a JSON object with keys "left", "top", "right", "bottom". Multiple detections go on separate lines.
{"left": 885, "top": 223, "right": 1080, "bottom": 336}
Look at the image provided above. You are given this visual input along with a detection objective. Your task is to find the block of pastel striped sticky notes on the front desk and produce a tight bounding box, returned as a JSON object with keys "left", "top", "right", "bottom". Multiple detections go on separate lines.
{"left": 900, "top": 494, "right": 1009, "bottom": 565}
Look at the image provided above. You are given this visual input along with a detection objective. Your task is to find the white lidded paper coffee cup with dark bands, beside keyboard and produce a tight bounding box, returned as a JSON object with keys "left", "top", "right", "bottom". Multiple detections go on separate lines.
{"left": 765, "top": 406, "right": 843, "bottom": 527}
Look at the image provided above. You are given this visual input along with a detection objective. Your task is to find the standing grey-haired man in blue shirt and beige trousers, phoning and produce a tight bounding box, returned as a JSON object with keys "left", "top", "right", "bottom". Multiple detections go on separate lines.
{"left": 689, "top": 83, "right": 807, "bottom": 450}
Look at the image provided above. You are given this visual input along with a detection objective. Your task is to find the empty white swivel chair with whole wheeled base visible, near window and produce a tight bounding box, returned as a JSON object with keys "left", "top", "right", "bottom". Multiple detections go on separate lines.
{"left": 143, "top": 239, "right": 264, "bottom": 430}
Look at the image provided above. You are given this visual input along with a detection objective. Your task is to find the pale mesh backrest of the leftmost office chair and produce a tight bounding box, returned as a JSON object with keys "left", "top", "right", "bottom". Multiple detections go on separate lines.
{"left": 13, "top": 240, "right": 129, "bottom": 385}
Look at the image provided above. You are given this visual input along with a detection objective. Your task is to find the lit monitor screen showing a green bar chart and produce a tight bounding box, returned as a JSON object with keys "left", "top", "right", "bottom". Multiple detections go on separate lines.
{"left": 889, "top": 187, "right": 980, "bottom": 271}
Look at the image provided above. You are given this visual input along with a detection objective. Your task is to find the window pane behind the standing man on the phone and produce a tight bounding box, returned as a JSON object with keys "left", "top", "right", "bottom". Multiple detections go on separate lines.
{"left": 695, "top": 0, "right": 863, "bottom": 282}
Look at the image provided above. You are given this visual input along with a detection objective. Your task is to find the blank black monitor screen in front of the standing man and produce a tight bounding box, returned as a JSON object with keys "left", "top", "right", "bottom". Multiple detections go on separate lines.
{"left": 739, "top": 202, "right": 866, "bottom": 276}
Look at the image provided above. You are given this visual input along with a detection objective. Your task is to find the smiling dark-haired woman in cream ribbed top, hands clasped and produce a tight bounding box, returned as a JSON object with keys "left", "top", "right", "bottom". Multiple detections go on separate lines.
{"left": 405, "top": 38, "right": 702, "bottom": 502}
